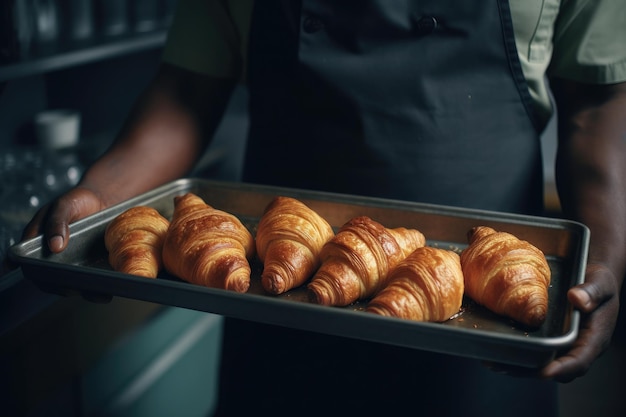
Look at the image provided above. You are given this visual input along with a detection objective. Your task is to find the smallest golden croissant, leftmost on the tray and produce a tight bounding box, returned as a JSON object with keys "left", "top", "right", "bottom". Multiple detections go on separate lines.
{"left": 104, "top": 206, "right": 169, "bottom": 278}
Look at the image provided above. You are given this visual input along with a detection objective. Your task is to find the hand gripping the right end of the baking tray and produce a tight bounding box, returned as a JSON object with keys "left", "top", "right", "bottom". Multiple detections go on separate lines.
{"left": 540, "top": 264, "right": 619, "bottom": 382}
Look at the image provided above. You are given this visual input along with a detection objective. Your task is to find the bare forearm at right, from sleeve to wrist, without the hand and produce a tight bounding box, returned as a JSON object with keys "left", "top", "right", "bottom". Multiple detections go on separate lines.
{"left": 554, "top": 81, "right": 626, "bottom": 289}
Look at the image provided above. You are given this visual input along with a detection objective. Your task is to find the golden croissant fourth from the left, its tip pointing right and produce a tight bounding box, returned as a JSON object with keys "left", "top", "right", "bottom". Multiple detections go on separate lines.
{"left": 307, "top": 216, "right": 426, "bottom": 306}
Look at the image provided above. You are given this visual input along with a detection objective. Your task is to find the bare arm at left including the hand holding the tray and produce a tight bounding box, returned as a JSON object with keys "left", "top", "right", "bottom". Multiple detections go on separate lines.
{"left": 24, "top": 64, "right": 235, "bottom": 247}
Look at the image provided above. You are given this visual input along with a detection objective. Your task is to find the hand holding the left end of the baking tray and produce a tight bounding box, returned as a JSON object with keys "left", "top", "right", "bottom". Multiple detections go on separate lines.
{"left": 22, "top": 186, "right": 104, "bottom": 253}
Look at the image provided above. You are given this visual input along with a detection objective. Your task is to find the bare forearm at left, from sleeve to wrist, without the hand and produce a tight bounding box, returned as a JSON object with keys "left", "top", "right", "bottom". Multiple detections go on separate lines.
{"left": 79, "top": 63, "right": 233, "bottom": 206}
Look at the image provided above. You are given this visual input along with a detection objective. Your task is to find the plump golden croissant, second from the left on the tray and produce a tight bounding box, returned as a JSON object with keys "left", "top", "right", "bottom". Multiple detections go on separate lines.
{"left": 163, "top": 193, "right": 254, "bottom": 292}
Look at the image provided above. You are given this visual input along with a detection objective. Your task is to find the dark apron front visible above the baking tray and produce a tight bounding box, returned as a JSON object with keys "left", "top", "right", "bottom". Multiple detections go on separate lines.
{"left": 244, "top": 0, "right": 543, "bottom": 213}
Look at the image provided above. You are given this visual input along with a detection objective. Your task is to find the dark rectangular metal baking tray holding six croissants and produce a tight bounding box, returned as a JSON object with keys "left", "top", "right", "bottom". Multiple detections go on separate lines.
{"left": 10, "top": 178, "right": 589, "bottom": 368}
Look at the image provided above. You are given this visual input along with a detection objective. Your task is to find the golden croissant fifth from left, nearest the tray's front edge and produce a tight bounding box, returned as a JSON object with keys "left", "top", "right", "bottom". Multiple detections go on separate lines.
{"left": 365, "top": 246, "right": 464, "bottom": 322}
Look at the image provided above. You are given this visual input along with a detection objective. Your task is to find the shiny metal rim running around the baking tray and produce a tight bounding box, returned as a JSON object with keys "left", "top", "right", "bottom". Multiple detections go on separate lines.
{"left": 9, "top": 178, "right": 589, "bottom": 366}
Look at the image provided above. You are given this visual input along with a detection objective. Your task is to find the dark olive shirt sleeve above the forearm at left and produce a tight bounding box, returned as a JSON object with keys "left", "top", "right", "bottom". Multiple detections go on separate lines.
{"left": 163, "top": 0, "right": 252, "bottom": 80}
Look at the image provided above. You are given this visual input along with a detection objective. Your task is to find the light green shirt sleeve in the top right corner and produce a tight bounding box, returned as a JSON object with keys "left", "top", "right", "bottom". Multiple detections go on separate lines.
{"left": 549, "top": 0, "right": 626, "bottom": 84}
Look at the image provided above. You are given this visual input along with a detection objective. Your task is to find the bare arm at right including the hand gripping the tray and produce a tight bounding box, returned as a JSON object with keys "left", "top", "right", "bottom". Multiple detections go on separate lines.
{"left": 541, "top": 79, "right": 626, "bottom": 382}
